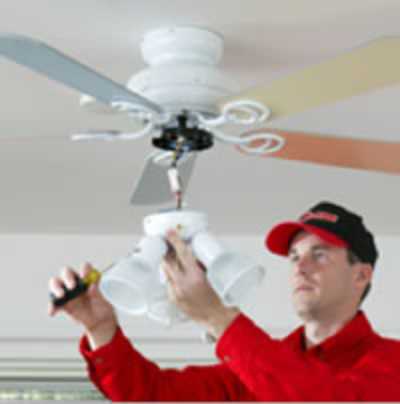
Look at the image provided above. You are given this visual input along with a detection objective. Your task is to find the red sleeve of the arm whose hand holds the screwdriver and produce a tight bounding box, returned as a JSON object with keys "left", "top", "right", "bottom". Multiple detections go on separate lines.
{"left": 80, "top": 329, "right": 252, "bottom": 401}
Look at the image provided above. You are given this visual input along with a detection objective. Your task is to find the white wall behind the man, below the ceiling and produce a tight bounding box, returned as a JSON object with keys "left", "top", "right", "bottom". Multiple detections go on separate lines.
{"left": 0, "top": 234, "right": 400, "bottom": 376}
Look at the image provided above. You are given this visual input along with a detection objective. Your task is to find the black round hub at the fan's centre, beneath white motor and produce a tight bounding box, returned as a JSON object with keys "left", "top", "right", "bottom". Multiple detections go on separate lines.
{"left": 152, "top": 114, "right": 214, "bottom": 151}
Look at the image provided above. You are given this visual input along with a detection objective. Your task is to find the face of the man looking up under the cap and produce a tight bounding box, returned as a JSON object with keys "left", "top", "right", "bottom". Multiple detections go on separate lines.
{"left": 289, "top": 231, "right": 359, "bottom": 321}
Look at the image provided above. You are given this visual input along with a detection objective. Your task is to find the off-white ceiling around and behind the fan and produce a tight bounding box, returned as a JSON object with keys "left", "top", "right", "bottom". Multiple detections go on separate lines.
{"left": 0, "top": 0, "right": 400, "bottom": 235}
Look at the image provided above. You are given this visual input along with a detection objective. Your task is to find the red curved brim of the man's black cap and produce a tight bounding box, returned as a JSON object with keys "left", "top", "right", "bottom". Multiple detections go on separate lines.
{"left": 265, "top": 222, "right": 349, "bottom": 256}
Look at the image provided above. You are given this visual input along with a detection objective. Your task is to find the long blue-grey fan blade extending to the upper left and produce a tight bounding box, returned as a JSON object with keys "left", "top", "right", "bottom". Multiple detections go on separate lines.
{"left": 0, "top": 33, "right": 162, "bottom": 113}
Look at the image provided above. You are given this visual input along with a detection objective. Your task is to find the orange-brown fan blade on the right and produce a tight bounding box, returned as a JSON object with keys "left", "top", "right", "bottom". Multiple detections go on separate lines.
{"left": 239, "top": 129, "right": 400, "bottom": 174}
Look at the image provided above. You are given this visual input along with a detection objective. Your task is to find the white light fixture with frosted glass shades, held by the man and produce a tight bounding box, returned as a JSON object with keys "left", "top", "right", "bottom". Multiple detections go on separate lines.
{"left": 100, "top": 211, "right": 265, "bottom": 325}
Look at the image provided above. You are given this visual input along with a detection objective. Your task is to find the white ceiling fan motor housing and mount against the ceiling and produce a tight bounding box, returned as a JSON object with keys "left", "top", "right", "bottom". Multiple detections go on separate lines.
{"left": 127, "top": 26, "right": 239, "bottom": 116}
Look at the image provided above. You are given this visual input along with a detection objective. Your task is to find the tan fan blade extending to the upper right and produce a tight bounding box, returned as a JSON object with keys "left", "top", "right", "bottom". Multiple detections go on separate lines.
{"left": 230, "top": 37, "right": 400, "bottom": 119}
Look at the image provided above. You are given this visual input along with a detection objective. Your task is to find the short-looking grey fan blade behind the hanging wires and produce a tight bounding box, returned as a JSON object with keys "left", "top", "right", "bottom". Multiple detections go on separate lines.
{"left": 130, "top": 151, "right": 197, "bottom": 205}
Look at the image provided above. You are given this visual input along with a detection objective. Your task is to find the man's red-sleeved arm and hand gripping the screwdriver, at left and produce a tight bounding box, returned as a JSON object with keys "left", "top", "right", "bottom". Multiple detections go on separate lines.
{"left": 49, "top": 258, "right": 251, "bottom": 401}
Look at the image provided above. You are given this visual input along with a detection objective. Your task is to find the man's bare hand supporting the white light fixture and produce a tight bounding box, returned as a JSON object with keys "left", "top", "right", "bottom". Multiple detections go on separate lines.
{"left": 162, "top": 230, "right": 240, "bottom": 338}
